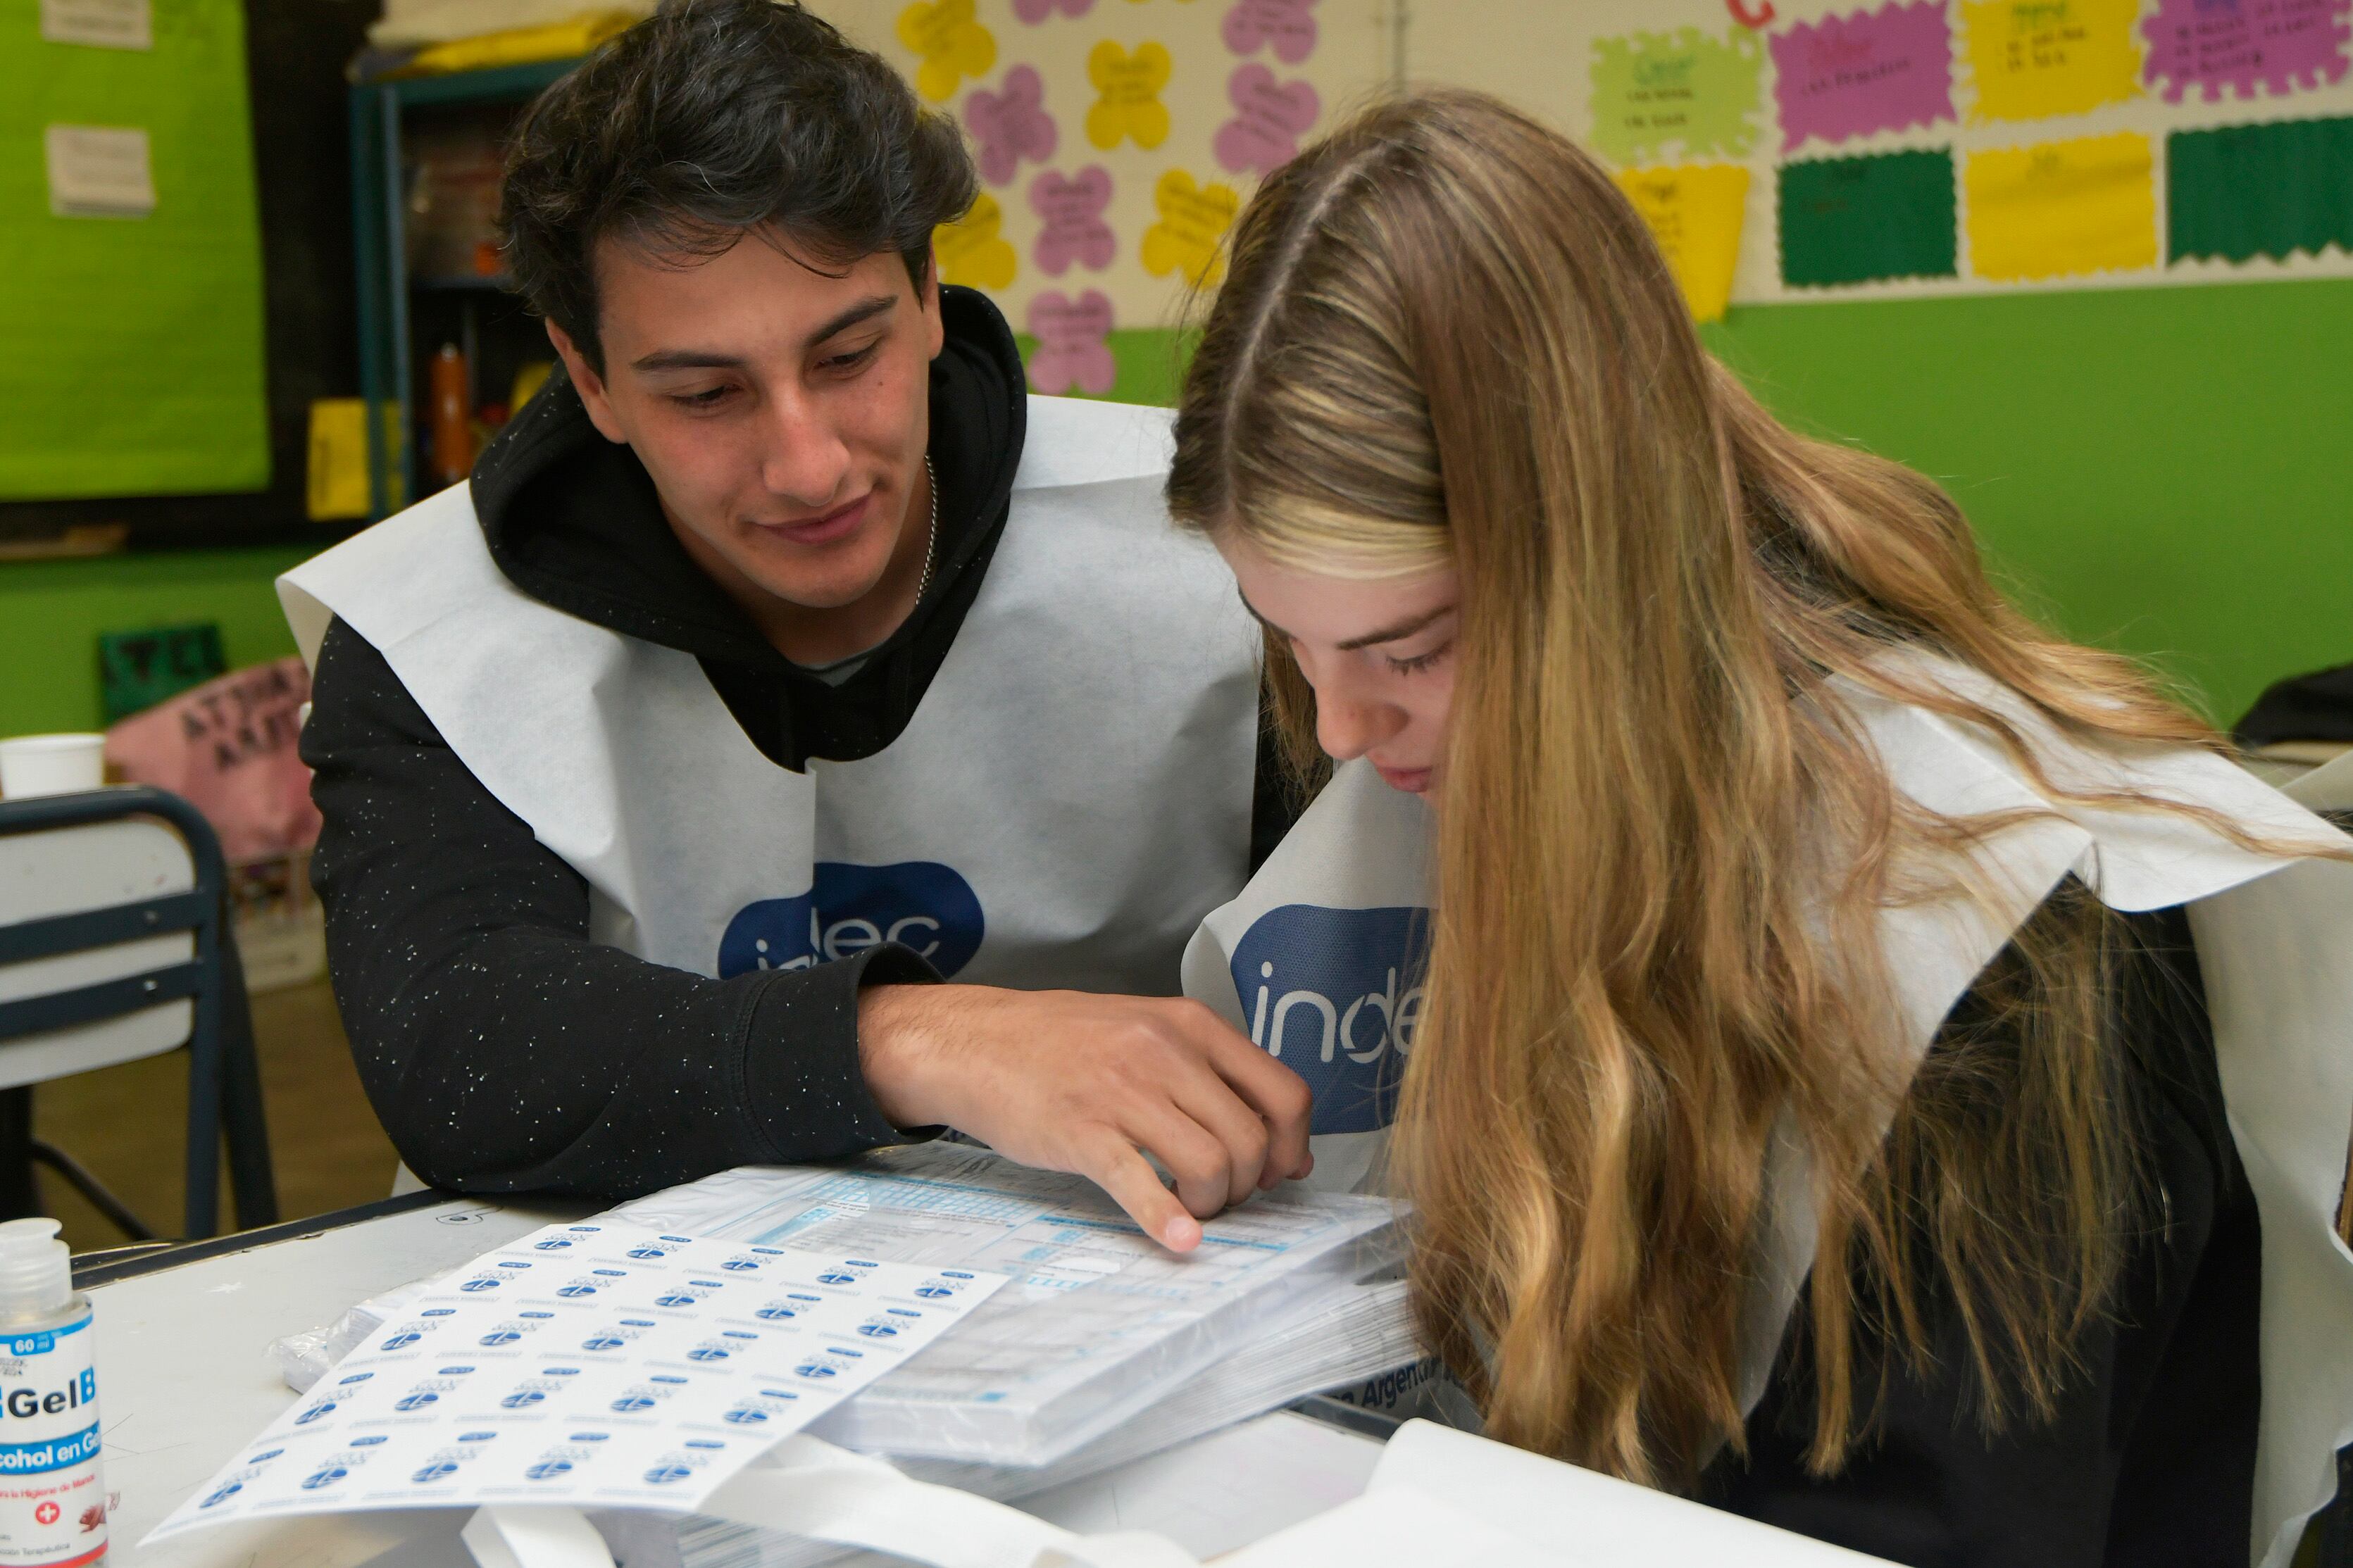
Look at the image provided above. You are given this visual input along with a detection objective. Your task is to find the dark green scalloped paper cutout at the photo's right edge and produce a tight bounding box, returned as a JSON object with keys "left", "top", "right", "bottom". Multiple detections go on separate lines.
{"left": 2165, "top": 120, "right": 2353, "bottom": 261}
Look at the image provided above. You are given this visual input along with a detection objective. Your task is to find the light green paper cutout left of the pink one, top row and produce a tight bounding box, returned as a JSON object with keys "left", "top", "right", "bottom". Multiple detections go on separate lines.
{"left": 1593, "top": 28, "right": 1765, "bottom": 165}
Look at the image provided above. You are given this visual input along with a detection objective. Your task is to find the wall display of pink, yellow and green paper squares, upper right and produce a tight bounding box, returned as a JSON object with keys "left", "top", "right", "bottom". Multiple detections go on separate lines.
{"left": 1412, "top": 0, "right": 2353, "bottom": 320}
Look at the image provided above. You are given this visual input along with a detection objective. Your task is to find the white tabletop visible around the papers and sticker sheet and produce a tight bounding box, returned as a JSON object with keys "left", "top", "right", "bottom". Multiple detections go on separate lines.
{"left": 87, "top": 1194, "right": 1381, "bottom": 1568}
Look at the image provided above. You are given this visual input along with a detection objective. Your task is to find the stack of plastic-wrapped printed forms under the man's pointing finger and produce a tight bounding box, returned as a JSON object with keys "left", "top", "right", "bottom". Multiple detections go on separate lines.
{"left": 614, "top": 1145, "right": 1400, "bottom": 1464}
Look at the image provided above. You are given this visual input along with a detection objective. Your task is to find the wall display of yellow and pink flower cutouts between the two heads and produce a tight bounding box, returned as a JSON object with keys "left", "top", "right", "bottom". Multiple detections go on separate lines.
{"left": 812, "top": 0, "right": 1398, "bottom": 397}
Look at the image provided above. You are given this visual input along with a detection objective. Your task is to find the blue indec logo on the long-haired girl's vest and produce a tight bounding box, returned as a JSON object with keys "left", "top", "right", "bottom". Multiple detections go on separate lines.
{"left": 1233, "top": 903, "right": 1430, "bottom": 1133}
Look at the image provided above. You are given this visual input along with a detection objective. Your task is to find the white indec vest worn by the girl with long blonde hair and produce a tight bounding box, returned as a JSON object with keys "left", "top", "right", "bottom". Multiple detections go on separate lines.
{"left": 1184, "top": 663, "right": 2353, "bottom": 1568}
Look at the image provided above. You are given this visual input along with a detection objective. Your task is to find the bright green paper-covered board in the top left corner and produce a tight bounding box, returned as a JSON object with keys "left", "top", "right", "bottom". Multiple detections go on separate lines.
{"left": 0, "top": 0, "right": 273, "bottom": 501}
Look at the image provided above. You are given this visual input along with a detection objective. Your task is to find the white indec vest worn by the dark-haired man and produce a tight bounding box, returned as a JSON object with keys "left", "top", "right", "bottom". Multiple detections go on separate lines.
{"left": 277, "top": 397, "right": 1259, "bottom": 994}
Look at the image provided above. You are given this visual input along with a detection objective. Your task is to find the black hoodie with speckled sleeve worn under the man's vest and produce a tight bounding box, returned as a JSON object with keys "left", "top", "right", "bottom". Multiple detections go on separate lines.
{"left": 301, "top": 289, "right": 1290, "bottom": 1196}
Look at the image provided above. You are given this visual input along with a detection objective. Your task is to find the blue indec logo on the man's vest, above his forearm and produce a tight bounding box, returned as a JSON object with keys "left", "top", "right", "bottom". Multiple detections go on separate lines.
{"left": 720, "top": 860, "right": 986, "bottom": 980}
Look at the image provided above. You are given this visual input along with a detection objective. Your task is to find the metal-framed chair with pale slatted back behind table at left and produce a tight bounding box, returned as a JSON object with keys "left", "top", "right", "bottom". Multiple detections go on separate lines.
{"left": 0, "top": 785, "right": 277, "bottom": 1239}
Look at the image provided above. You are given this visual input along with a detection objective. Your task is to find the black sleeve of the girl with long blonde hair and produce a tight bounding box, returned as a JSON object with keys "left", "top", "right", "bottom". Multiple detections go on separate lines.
{"left": 1702, "top": 910, "right": 2261, "bottom": 1568}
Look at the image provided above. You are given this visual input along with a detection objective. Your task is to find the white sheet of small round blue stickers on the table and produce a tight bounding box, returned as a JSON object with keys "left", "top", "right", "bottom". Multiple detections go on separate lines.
{"left": 141, "top": 1225, "right": 1005, "bottom": 1545}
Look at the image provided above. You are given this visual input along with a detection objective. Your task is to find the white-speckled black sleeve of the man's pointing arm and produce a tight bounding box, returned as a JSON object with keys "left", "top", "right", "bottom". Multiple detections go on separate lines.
{"left": 301, "top": 620, "right": 932, "bottom": 1196}
